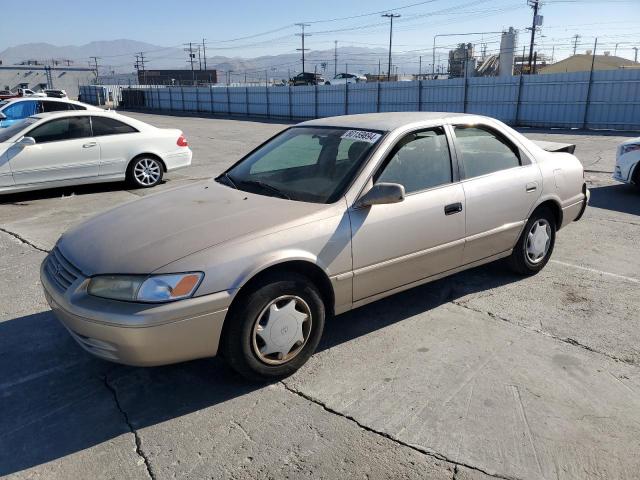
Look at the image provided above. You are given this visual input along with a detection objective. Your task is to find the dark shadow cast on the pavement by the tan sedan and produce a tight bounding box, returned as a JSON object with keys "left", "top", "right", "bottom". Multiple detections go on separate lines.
{"left": 0, "top": 263, "right": 521, "bottom": 476}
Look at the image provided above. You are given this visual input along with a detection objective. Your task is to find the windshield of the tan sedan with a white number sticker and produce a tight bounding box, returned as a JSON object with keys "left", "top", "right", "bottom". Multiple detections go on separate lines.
{"left": 217, "top": 127, "right": 382, "bottom": 203}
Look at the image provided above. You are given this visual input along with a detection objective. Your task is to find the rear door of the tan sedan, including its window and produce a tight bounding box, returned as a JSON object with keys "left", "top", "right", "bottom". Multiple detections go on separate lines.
{"left": 453, "top": 123, "right": 542, "bottom": 264}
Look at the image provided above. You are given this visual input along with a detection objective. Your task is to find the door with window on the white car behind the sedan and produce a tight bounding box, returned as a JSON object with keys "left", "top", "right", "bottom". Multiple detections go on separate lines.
{"left": 10, "top": 116, "right": 100, "bottom": 185}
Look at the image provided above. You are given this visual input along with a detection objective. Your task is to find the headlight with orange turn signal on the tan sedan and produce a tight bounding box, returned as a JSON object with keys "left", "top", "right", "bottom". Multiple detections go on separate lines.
{"left": 87, "top": 272, "right": 204, "bottom": 303}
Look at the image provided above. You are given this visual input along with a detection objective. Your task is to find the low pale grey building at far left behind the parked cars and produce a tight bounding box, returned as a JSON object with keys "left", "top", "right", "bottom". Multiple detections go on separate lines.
{"left": 0, "top": 62, "right": 96, "bottom": 98}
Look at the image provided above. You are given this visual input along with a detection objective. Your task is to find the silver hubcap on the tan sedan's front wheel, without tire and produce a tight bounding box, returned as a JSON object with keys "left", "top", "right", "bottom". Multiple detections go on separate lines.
{"left": 252, "top": 295, "right": 312, "bottom": 365}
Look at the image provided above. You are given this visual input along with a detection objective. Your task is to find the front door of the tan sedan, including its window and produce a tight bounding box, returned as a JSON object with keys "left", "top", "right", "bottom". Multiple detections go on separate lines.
{"left": 349, "top": 127, "right": 465, "bottom": 302}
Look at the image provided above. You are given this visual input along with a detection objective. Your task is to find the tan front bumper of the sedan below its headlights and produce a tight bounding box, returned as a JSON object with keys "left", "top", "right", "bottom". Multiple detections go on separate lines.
{"left": 40, "top": 254, "right": 231, "bottom": 366}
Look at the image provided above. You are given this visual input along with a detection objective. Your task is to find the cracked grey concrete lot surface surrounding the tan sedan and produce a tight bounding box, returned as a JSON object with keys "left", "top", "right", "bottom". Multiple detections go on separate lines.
{"left": 0, "top": 112, "right": 640, "bottom": 479}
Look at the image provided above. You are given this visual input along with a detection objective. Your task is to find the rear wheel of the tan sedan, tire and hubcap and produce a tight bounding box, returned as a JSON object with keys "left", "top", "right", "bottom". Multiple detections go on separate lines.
{"left": 508, "top": 207, "right": 556, "bottom": 275}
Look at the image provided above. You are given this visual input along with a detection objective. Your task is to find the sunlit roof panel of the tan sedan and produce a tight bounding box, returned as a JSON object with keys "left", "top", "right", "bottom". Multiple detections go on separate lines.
{"left": 299, "top": 112, "right": 479, "bottom": 132}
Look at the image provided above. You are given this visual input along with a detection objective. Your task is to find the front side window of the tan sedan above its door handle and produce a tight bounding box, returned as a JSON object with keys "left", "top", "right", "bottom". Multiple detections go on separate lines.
{"left": 375, "top": 128, "right": 452, "bottom": 193}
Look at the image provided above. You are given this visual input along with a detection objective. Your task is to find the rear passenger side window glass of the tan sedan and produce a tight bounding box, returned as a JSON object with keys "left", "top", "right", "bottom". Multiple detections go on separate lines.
{"left": 455, "top": 126, "right": 520, "bottom": 178}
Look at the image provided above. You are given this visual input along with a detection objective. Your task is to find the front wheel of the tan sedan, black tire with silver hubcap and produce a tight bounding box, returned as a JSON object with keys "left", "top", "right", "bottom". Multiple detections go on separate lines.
{"left": 220, "top": 272, "right": 326, "bottom": 382}
